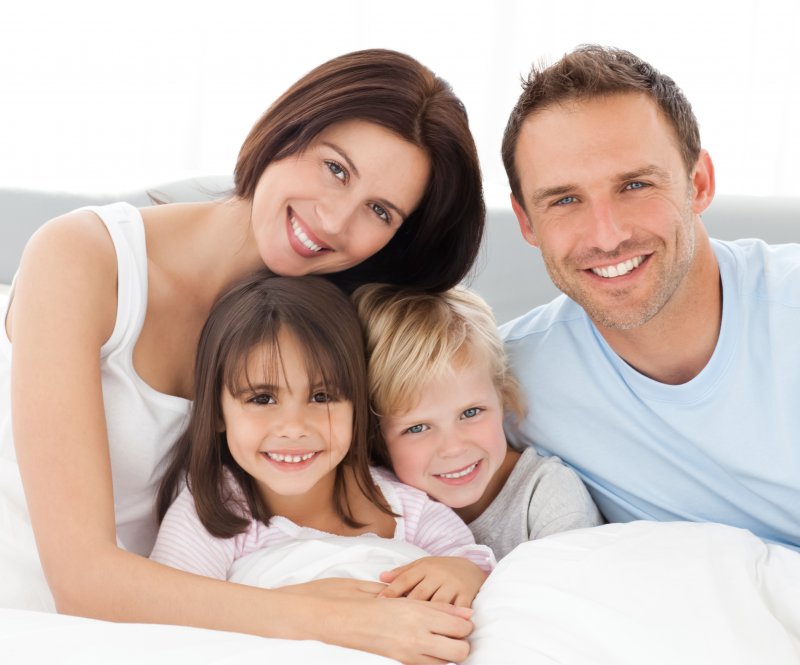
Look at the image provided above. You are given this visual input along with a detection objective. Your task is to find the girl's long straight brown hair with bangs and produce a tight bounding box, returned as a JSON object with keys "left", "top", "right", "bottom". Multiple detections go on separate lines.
{"left": 156, "top": 270, "right": 391, "bottom": 538}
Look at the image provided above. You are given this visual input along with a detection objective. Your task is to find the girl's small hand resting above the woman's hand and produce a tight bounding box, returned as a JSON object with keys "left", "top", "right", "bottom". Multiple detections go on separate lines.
{"left": 378, "top": 556, "right": 487, "bottom": 607}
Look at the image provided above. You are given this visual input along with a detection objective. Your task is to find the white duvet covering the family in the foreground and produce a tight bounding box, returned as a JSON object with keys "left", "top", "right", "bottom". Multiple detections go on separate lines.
{"left": 0, "top": 522, "right": 800, "bottom": 665}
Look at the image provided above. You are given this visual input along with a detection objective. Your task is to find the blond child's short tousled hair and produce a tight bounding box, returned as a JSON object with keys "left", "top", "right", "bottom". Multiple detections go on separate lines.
{"left": 353, "top": 284, "right": 525, "bottom": 440}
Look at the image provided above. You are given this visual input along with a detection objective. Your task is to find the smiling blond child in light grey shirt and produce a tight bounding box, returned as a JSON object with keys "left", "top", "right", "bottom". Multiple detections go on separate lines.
{"left": 354, "top": 285, "right": 602, "bottom": 559}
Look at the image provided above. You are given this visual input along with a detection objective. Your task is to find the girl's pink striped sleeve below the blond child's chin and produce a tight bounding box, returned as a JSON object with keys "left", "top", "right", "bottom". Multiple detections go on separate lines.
{"left": 403, "top": 482, "right": 497, "bottom": 573}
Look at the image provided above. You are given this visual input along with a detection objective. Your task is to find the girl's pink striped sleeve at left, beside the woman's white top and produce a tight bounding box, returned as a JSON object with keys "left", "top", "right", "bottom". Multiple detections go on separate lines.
{"left": 150, "top": 488, "right": 235, "bottom": 580}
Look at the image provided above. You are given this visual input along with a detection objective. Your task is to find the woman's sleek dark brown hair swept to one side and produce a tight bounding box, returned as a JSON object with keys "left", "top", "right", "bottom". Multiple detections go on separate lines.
{"left": 235, "top": 49, "right": 486, "bottom": 291}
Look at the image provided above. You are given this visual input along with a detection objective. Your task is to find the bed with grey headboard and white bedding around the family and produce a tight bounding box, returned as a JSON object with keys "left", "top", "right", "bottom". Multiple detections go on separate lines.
{"left": 0, "top": 178, "right": 800, "bottom": 665}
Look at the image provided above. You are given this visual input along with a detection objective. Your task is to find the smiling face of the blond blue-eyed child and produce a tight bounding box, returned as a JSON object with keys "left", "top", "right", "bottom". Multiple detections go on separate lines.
{"left": 381, "top": 362, "right": 507, "bottom": 508}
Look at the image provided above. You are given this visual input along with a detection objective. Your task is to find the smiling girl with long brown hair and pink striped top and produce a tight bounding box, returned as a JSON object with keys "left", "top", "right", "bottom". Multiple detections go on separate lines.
{"left": 151, "top": 272, "right": 493, "bottom": 607}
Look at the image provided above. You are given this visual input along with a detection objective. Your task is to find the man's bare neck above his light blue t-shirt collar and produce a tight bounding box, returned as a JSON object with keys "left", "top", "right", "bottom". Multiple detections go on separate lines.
{"left": 597, "top": 234, "right": 722, "bottom": 385}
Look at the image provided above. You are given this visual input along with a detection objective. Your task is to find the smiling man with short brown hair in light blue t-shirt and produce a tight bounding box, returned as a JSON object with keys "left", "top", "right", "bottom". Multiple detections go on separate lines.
{"left": 503, "top": 45, "right": 800, "bottom": 548}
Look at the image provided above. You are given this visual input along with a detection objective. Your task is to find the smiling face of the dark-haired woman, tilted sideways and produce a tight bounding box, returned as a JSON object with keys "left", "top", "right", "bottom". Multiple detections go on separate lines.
{"left": 251, "top": 120, "right": 430, "bottom": 276}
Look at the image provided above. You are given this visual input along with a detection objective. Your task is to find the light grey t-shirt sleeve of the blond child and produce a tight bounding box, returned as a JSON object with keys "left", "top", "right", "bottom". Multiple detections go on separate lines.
{"left": 528, "top": 458, "right": 604, "bottom": 540}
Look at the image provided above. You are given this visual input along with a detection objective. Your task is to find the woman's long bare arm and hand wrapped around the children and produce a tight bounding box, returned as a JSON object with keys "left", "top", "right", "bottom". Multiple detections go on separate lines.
{"left": 8, "top": 212, "right": 471, "bottom": 662}
